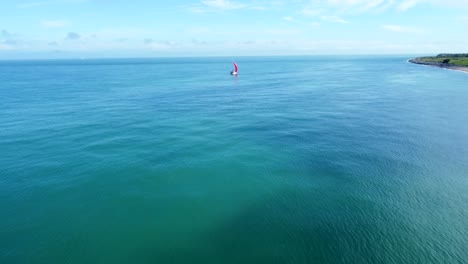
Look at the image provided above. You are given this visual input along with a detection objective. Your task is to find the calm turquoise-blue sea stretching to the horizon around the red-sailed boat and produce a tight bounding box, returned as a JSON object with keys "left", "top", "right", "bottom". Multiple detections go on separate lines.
{"left": 0, "top": 56, "right": 468, "bottom": 264}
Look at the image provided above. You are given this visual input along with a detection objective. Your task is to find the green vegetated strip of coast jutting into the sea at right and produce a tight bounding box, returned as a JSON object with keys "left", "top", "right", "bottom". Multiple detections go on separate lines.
{"left": 409, "top": 53, "right": 468, "bottom": 72}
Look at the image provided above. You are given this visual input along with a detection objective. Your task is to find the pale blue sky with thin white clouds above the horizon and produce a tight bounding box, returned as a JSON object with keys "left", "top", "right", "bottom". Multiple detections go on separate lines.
{"left": 0, "top": 0, "right": 468, "bottom": 59}
